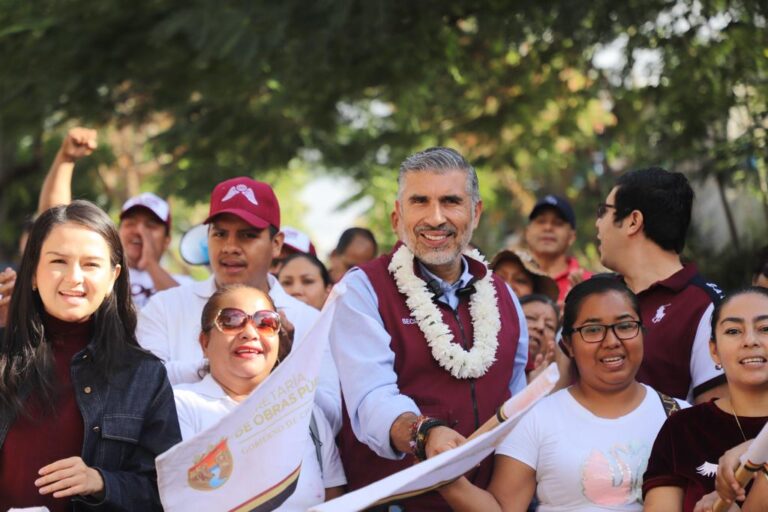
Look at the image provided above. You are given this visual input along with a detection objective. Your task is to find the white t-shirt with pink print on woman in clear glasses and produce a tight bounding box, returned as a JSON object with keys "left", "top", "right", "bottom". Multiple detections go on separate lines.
{"left": 496, "top": 386, "right": 688, "bottom": 512}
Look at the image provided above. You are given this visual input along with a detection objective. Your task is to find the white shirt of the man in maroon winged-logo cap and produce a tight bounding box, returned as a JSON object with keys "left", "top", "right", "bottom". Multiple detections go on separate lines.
{"left": 136, "top": 275, "right": 341, "bottom": 432}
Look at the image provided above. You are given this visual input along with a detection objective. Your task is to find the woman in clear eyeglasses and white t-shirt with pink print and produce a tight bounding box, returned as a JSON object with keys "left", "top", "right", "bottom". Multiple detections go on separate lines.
{"left": 441, "top": 277, "right": 685, "bottom": 512}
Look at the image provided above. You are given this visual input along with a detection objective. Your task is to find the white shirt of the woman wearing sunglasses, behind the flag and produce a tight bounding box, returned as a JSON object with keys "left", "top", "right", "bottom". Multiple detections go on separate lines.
{"left": 173, "top": 374, "right": 347, "bottom": 512}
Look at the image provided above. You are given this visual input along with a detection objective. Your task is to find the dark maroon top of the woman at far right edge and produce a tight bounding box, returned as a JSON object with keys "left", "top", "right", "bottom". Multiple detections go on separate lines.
{"left": 643, "top": 401, "right": 768, "bottom": 512}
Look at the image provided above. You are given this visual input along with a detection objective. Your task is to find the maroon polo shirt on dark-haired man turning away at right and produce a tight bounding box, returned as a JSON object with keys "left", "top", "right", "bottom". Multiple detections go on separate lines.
{"left": 637, "top": 263, "right": 725, "bottom": 400}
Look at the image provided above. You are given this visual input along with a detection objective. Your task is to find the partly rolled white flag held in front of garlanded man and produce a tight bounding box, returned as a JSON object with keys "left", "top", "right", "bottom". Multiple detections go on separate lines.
{"left": 310, "top": 363, "right": 560, "bottom": 512}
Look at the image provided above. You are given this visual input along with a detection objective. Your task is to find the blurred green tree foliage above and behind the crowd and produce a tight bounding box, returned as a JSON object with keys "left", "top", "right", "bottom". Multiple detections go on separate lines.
{"left": 0, "top": 0, "right": 768, "bottom": 278}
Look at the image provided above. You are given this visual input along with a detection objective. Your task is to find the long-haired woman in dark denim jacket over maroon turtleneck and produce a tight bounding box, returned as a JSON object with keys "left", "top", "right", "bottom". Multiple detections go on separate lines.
{"left": 0, "top": 201, "right": 181, "bottom": 511}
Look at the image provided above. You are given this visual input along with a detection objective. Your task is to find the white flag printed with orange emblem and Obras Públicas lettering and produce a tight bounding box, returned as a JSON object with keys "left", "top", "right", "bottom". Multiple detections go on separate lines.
{"left": 156, "top": 286, "right": 343, "bottom": 512}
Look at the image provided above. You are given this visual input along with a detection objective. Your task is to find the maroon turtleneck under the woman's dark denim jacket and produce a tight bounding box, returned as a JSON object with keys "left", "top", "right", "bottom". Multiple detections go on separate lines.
{"left": 0, "top": 317, "right": 92, "bottom": 512}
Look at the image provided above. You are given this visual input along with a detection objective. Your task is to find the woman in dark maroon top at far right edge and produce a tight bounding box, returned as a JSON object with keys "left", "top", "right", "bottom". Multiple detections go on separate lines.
{"left": 643, "top": 287, "right": 768, "bottom": 512}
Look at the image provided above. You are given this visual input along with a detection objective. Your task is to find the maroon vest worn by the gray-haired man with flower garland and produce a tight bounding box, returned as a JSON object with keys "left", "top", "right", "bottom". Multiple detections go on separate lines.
{"left": 339, "top": 244, "right": 520, "bottom": 512}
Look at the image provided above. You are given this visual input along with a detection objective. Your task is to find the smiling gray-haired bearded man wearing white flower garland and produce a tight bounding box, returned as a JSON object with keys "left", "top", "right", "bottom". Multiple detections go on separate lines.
{"left": 331, "top": 147, "right": 528, "bottom": 510}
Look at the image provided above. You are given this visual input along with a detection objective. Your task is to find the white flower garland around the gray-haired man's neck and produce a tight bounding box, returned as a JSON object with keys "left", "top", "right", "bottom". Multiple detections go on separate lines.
{"left": 388, "top": 245, "right": 501, "bottom": 379}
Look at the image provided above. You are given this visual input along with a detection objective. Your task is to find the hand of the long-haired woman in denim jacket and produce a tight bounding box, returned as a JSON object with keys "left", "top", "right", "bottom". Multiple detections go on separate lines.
{"left": 35, "top": 457, "right": 104, "bottom": 498}
